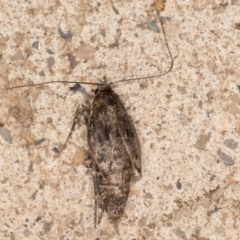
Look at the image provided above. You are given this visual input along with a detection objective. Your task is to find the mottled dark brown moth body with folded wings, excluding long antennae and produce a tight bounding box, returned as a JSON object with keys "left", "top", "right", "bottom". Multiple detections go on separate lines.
{"left": 85, "top": 84, "right": 141, "bottom": 226}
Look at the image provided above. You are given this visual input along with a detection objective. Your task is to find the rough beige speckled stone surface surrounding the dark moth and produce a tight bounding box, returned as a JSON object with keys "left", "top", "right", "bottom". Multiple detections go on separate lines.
{"left": 0, "top": 0, "right": 240, "bottom": 240}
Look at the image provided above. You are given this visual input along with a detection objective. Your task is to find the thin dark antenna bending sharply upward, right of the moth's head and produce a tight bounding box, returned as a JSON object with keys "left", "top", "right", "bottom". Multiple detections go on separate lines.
{"left": 109, "top": 10, "right": 174, "bottom": 85}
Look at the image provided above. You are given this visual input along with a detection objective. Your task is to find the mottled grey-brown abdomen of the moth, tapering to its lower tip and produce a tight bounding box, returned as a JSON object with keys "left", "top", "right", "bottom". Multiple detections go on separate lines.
{"left": 98, "top": 133, "right": 132, "bottom": 220}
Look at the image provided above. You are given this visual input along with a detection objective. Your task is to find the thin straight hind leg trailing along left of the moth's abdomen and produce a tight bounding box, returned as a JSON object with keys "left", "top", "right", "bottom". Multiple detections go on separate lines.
{"left": 92, "top": 161, "right": 104, "bottom": 228}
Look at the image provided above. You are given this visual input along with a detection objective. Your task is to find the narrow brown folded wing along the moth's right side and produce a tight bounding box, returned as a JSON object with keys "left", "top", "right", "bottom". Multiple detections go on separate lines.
{"left": 116, "top": 96, "right": 141, "bottom": 174}
